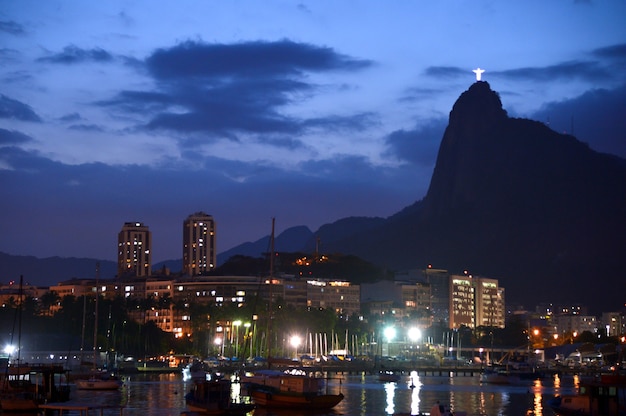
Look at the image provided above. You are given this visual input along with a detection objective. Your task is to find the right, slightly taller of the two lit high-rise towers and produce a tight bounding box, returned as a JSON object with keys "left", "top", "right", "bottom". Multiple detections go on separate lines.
{"left": 183, "top": 212, "right": 217, "bottom": 276}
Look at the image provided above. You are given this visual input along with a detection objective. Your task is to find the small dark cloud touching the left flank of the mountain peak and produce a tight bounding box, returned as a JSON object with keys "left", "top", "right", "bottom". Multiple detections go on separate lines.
{"left": 384, "top": 119, "right": 448, "bottom": 168}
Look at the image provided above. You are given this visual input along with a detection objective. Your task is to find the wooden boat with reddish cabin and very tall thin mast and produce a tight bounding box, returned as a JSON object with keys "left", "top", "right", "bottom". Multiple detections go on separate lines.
{"left": 241, "top": 218, "right": 344, "bottom": 410}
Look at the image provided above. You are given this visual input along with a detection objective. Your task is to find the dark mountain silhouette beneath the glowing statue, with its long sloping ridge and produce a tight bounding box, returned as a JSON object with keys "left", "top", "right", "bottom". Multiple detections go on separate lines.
{"left": 0, "top": 81, "right": 626, "bottom": 316}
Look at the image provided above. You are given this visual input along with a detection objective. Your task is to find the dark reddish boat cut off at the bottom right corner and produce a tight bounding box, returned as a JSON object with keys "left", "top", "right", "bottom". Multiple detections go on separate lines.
{"left": 547, "top": 374, "right": 626, "bottom": 416}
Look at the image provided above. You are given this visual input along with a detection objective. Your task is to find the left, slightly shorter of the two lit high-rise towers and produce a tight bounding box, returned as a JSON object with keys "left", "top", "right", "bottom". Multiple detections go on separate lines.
{"left": 117, "top": 222, "right": 152, "bottom": 277}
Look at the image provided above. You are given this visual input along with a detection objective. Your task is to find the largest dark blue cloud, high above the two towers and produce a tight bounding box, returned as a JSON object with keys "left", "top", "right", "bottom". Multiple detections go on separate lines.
{"left": 100, "top": 40, "right": 371, "bottom": 144}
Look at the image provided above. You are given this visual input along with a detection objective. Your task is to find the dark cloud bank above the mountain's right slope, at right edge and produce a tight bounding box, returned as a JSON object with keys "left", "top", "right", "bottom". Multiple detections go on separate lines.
{"left": 532, "top": 84, "right": 626, "bottom": 159}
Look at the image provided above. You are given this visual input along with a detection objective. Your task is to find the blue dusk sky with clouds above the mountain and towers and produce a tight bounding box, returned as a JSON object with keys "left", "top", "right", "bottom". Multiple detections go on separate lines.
{"left": 0, "top": 0, "right": 626, "bottom": 262}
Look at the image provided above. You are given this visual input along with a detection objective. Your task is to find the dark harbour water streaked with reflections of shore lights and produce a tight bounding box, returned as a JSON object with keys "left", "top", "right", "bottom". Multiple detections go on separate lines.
{"left": 6, "top": 374, "right": 576, "bottom": 416}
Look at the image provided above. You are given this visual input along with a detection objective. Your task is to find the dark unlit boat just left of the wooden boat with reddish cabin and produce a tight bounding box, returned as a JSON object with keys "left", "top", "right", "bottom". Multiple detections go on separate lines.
{"left": 185, "top": 378, "right": 254, "bottom": 416}
